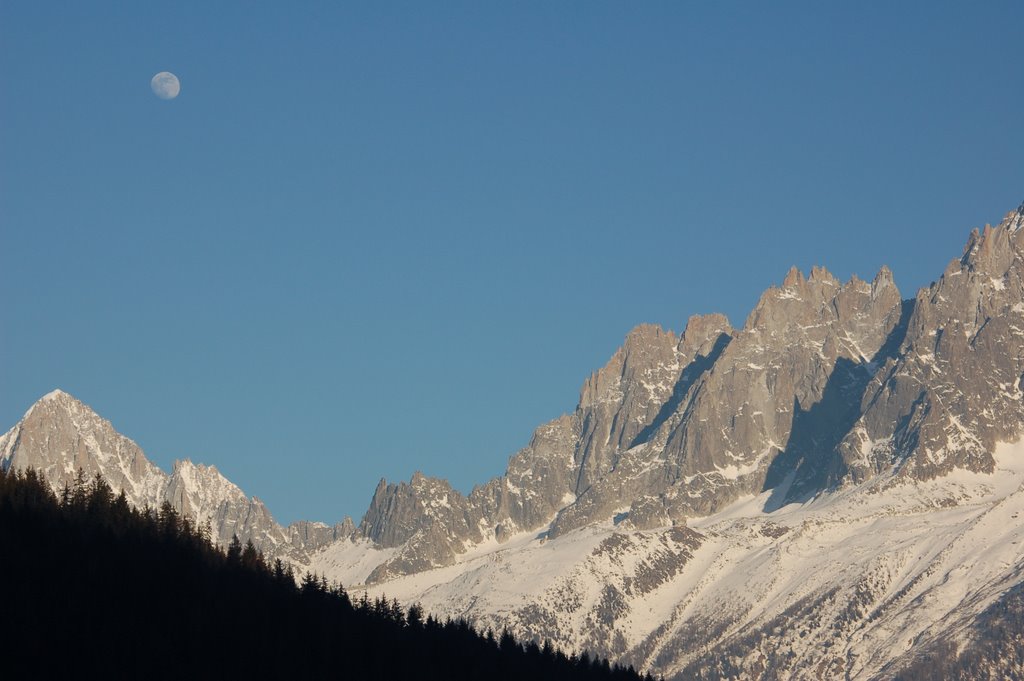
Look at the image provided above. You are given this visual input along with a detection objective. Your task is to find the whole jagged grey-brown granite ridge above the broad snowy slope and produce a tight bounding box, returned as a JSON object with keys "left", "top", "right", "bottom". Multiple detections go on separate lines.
{"left": 360, "top": 199, "right": 1024, "bottom": 581}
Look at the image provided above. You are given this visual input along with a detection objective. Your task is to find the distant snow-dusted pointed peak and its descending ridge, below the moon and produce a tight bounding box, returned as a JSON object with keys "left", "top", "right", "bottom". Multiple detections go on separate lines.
{"left": 0, "top": 390, "right": 354, "bottom": 565}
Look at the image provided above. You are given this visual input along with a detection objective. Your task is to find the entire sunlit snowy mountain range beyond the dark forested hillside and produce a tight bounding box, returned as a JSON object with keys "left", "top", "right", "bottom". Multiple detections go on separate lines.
{"left": 8, "top": 199, "right": 1024, "bottom": 679}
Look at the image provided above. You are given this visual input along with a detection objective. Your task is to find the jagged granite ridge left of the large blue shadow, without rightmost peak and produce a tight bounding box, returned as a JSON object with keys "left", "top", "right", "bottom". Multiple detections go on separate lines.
{"left": 352, "top": 261, "right": 904, "bottom": 569}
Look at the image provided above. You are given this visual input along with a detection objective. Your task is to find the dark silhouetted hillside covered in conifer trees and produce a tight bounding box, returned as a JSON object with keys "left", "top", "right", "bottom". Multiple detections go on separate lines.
{"left": 0, "top": 471, "right": 651, "bottom": 681}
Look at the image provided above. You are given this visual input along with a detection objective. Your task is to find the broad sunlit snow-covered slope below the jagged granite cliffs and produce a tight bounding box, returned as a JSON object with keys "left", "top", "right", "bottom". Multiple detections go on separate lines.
{"left": 312, "top": 442, "right": 1024, "bottom": 679}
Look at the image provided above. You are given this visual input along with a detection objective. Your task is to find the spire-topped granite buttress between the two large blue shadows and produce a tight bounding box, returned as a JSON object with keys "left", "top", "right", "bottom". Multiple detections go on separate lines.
{"left": 552, "top": 267, "right": 902, "bottom": 536}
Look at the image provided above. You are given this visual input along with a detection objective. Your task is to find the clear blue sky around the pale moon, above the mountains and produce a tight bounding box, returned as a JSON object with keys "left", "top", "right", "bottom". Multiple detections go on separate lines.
{"left": 0, "top": 0, "right": 1024, "bottom": 522}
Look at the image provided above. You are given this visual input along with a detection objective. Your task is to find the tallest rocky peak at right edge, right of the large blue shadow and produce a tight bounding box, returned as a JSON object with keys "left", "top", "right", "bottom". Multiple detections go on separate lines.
{"left": 839, "top": 205, "right": 1024, "bottom": 479}
